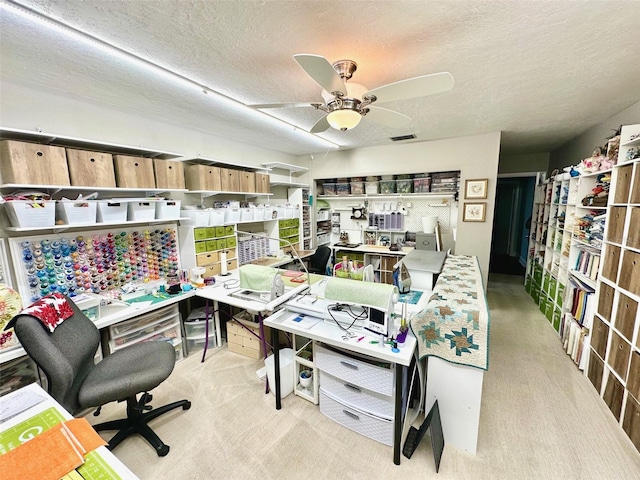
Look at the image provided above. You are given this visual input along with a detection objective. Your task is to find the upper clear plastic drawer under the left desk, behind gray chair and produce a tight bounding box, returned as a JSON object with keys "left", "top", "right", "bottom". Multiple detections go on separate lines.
{"left": 109, "top": 305, "right": 180, "bottom": 351}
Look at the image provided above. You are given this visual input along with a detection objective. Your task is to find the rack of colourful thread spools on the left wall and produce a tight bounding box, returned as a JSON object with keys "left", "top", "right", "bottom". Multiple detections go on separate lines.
{"left": 9, "top": 224, "right": 180, "bottom": 305}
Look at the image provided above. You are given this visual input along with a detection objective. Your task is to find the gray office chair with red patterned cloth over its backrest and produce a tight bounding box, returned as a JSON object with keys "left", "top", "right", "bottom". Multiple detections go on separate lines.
{"left": 6, "top": 294, "right": 191, "bottom": 457}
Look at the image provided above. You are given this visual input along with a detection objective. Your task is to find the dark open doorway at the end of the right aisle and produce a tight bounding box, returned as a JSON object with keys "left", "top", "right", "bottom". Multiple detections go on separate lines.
{"left": 489, "top": 174, "right": 537, "bottom": 276}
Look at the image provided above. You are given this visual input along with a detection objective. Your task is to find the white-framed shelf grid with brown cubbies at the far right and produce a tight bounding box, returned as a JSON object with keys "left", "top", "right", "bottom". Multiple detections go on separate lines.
{"left": 586, "top": 125, "right": 640, "bottom": 451}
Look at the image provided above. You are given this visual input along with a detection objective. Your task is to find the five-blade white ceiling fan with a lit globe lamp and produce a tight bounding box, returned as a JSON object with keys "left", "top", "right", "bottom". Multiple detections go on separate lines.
{"left": 249, "top": 54, "right": 453, "bottom": 133}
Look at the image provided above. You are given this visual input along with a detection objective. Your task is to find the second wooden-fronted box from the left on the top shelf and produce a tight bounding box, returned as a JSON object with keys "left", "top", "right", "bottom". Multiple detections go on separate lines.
{"left": 67, "top": 148, "right": 116, "bottom": 187}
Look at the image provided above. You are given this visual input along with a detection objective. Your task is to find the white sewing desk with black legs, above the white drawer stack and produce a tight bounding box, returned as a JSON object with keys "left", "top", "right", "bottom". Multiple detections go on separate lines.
{"left": 264, "top": 287, "right": 428, "bottom": 465}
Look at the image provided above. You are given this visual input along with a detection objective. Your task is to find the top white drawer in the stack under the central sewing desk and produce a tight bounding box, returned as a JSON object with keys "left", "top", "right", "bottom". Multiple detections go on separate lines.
{"left": 316, "top": 345, "right": 395, "bottom": 396}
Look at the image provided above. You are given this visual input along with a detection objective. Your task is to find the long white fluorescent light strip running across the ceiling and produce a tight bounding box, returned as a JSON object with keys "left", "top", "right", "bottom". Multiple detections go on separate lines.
{"left": 0, "top": 0, "right": 340, "bottom": 148}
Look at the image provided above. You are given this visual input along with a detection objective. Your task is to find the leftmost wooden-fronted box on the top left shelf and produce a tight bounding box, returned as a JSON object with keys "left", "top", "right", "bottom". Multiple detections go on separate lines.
{"left": 0, "top": 140, "right": 71, "bottom": 186}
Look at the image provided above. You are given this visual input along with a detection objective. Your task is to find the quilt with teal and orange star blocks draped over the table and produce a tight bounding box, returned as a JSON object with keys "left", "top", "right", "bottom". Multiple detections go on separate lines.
{"left": 410, "top": 255, "right": 489, "bottom": 370}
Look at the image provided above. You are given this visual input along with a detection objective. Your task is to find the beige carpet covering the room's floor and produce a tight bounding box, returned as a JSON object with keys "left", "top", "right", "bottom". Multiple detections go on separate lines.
{"left": 88, "top": 275, "right": 640, "bottom": 480}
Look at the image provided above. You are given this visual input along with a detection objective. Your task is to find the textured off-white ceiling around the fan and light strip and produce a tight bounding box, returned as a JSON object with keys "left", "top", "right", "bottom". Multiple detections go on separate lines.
{"left": 0, "top": 0, "right": 640, "bottom": 154}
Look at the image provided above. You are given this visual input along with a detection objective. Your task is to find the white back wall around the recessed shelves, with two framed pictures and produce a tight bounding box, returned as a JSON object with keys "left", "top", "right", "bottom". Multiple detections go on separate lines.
{"left": 302, "top": 132, "right": 500, "bottom": 287}
